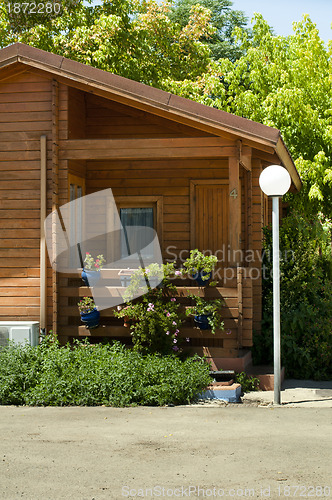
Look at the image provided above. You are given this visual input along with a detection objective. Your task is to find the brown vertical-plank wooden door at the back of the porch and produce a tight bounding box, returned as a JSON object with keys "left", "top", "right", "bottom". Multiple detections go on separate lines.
{"left": 191, "top": 180, "right": 229, "bottom": 267}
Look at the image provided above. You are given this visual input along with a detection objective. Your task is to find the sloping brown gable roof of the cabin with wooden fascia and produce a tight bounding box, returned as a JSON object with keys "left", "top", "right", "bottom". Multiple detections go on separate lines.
{"left": 0, "top": 43, "right": 301, "bottom": 189}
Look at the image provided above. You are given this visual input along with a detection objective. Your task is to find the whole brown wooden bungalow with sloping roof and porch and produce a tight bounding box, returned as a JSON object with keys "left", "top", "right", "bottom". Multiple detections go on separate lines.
{"left": 0, "top": 43, "right": 301, "bottom": 368}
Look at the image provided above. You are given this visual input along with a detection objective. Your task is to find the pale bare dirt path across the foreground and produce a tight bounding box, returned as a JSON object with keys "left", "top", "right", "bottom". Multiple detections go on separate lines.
{"left": 0, "top": 405, "right": 332, "bottom": 500}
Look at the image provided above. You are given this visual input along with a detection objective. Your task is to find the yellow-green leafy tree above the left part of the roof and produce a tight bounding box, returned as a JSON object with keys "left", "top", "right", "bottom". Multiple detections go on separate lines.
{"left": 0, "top": 0, "right": 214, "bottom": 87}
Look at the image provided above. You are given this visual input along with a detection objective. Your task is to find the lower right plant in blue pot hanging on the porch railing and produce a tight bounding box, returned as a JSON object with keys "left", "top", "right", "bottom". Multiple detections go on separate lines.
{"left": 186, "top": 295, "right": 224, "bottom": 334}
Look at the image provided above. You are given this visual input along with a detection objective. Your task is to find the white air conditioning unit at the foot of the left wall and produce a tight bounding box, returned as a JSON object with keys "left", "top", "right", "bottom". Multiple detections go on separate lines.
{"left": 0, "top": 321, "right": 39, "bottom": 347}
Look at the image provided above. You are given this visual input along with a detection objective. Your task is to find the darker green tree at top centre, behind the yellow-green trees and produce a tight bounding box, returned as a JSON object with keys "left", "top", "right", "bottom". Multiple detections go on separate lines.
{"left": 169, "top": 0, "right": 250, "bottom": 61}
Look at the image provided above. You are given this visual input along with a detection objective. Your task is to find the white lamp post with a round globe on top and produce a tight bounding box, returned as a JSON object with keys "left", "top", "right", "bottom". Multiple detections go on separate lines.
{"left": 259, "top": 165, "right": 291, "bottom": 405}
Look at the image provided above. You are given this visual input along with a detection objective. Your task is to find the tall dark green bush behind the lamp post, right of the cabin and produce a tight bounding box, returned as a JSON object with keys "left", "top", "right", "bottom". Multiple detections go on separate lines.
{"left": 253, "top": 214, "right": 332, "bottom": 380}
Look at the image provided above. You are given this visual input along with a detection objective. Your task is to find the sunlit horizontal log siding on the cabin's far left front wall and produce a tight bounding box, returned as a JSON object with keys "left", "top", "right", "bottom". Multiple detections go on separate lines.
{"left": 0, "top": 72, "right": 52, "bottom": 321}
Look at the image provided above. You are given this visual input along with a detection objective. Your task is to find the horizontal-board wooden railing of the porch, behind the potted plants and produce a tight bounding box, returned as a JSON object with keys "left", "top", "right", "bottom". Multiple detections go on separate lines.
{"left": 58, "top": 268, "right": 252, "bottom": 358}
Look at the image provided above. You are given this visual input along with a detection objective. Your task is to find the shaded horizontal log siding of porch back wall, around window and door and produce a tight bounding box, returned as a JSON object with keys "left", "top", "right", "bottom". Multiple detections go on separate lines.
{"left": 86, "top": 160, "right": 228, "bottom": 259}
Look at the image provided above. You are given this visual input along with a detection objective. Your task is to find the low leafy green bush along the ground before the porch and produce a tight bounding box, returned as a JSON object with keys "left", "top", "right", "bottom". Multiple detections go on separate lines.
{"left": 0, "top": 338, "right": 211, "bottom": 406}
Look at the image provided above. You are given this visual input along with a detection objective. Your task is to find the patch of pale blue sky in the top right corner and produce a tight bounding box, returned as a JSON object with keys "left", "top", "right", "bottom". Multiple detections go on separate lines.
{"left": 232, "top": 0, "right": 332, "bottom": 43}
